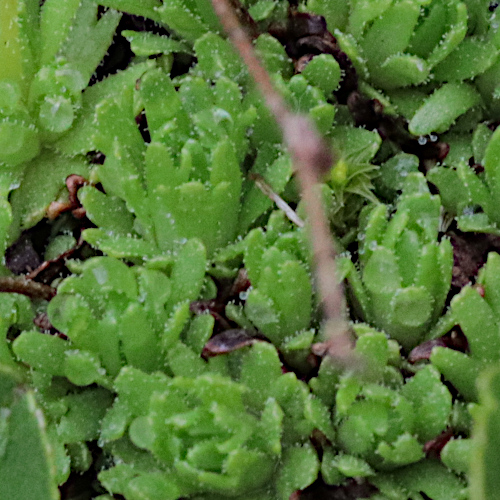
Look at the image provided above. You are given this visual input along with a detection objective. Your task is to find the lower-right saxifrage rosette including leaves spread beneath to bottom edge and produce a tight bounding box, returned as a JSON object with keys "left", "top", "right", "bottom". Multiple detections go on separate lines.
{"left": 309, "top": 324, "right": 467, "bottom": 499}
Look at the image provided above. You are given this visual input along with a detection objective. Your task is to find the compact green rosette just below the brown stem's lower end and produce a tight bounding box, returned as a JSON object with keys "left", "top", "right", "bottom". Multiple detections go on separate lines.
{"left": 330, "top": 326, "right": 451, "bottom": 472}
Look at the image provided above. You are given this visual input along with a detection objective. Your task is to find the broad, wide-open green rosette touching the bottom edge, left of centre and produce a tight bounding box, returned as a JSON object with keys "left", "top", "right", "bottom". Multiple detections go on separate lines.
{"left": 100, "top": 343, "right": 333, "bottom": 500}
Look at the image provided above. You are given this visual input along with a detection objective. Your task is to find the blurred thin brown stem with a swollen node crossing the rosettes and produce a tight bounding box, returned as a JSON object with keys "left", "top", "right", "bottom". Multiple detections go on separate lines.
{"left": 212, "top": 0, "right": 351, "bottom": 359}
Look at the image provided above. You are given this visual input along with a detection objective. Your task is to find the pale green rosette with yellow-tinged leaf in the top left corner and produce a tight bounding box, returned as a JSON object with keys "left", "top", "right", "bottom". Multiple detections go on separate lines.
{"left": 0, "top": 0, "right": 120, "bottom": 167}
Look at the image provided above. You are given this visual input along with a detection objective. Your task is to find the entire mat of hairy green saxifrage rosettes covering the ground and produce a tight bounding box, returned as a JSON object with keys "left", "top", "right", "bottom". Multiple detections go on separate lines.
{"left": 0, "top": 0, "right": 500, "bottom": 500}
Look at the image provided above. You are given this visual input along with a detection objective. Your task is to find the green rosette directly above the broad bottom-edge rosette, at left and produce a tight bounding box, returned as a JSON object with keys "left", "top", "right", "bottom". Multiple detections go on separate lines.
{"left": 13, "top": 250, "right": 206, "bottom": 378}
